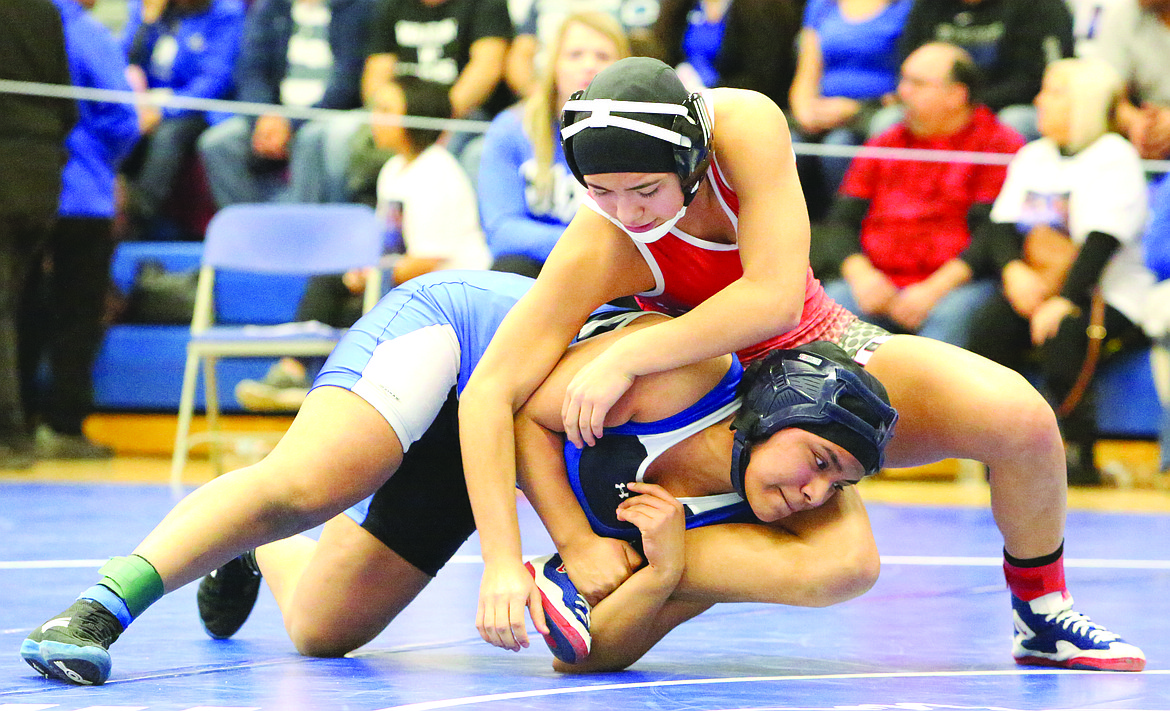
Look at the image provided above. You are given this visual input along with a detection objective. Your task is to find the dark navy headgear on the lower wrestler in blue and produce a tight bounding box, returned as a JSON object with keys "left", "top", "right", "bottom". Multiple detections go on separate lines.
{"left": 731, "top": 340, "right": 897, "bottom": 499}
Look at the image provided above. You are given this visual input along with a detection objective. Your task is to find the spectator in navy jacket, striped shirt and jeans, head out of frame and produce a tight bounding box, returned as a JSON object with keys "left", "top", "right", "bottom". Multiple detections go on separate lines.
{"left": 199, "top": 0, "right": 373, "bottom": 207}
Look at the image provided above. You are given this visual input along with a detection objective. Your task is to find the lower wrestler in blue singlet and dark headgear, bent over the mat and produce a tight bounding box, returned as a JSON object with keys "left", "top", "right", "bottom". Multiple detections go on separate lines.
{"left": 21, "top": 270, "right": 896, "bottom": 684}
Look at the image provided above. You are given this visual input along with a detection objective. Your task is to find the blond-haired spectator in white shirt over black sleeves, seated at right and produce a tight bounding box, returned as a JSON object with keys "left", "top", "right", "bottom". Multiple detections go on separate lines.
{"left": 971, "top": 60, "right": 1154, "bottom": 484}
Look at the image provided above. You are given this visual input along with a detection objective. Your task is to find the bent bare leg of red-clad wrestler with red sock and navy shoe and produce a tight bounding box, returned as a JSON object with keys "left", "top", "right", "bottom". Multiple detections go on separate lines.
{"left": 866, "top": 336, "right": 1145, "bottom": 671}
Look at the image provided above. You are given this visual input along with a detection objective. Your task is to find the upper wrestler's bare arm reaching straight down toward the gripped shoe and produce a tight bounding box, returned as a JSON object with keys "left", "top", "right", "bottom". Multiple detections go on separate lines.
{"left": 459, "top": 208, "right": 653, "bottom": 650}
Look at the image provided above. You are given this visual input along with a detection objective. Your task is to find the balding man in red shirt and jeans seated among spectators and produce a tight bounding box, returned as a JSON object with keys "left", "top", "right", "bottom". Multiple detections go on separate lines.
{"left": 817, "top": 42, "right": 1024, "bottom": 347}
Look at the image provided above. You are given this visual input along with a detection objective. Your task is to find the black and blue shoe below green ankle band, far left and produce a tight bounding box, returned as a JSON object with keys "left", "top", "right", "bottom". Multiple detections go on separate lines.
{"left": 20, "top": 600, "right": 122, "bottom": 685}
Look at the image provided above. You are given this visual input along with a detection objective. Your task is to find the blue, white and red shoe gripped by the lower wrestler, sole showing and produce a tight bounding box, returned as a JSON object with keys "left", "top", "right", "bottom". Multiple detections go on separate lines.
{"left": 524, "top": 553, "right": 593, "bottom": 664}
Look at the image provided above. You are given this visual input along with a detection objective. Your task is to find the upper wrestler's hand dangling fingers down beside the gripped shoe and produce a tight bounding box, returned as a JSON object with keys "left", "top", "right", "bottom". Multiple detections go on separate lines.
{"left": 475, "top": 560, "right": 549, "bottom": 651}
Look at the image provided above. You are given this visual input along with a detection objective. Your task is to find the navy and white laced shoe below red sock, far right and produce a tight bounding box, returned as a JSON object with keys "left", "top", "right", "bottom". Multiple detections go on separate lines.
{"left": 1012, "top": 593, "right": 1145, "bottom": 671}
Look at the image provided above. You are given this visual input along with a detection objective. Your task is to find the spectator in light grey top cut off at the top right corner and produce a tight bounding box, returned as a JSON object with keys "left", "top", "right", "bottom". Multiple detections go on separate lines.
{"left": 1096, "top": 0, "right": 1170, "bottom": 159}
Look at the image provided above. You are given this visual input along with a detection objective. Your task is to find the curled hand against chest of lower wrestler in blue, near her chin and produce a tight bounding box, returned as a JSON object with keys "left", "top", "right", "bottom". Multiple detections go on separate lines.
{"left": 618, "top": 482, "right": 687, "bottom": 584}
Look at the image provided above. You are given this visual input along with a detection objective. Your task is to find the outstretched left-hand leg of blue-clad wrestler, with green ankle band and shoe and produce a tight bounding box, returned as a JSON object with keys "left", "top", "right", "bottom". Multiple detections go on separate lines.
{"left": 21, "top": 387, "right": 402, "bottom": 684}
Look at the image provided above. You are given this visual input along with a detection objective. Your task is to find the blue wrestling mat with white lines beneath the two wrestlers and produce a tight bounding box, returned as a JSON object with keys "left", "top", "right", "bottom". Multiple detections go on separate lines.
{"left": 0, "top": 483, "right": 1170, "bottom": 711}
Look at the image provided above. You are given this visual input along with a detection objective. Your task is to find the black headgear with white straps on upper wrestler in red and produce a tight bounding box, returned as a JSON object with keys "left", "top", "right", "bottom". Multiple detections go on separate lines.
{"left": 560, "top": 57, "right": 711, "bottom": 205}
